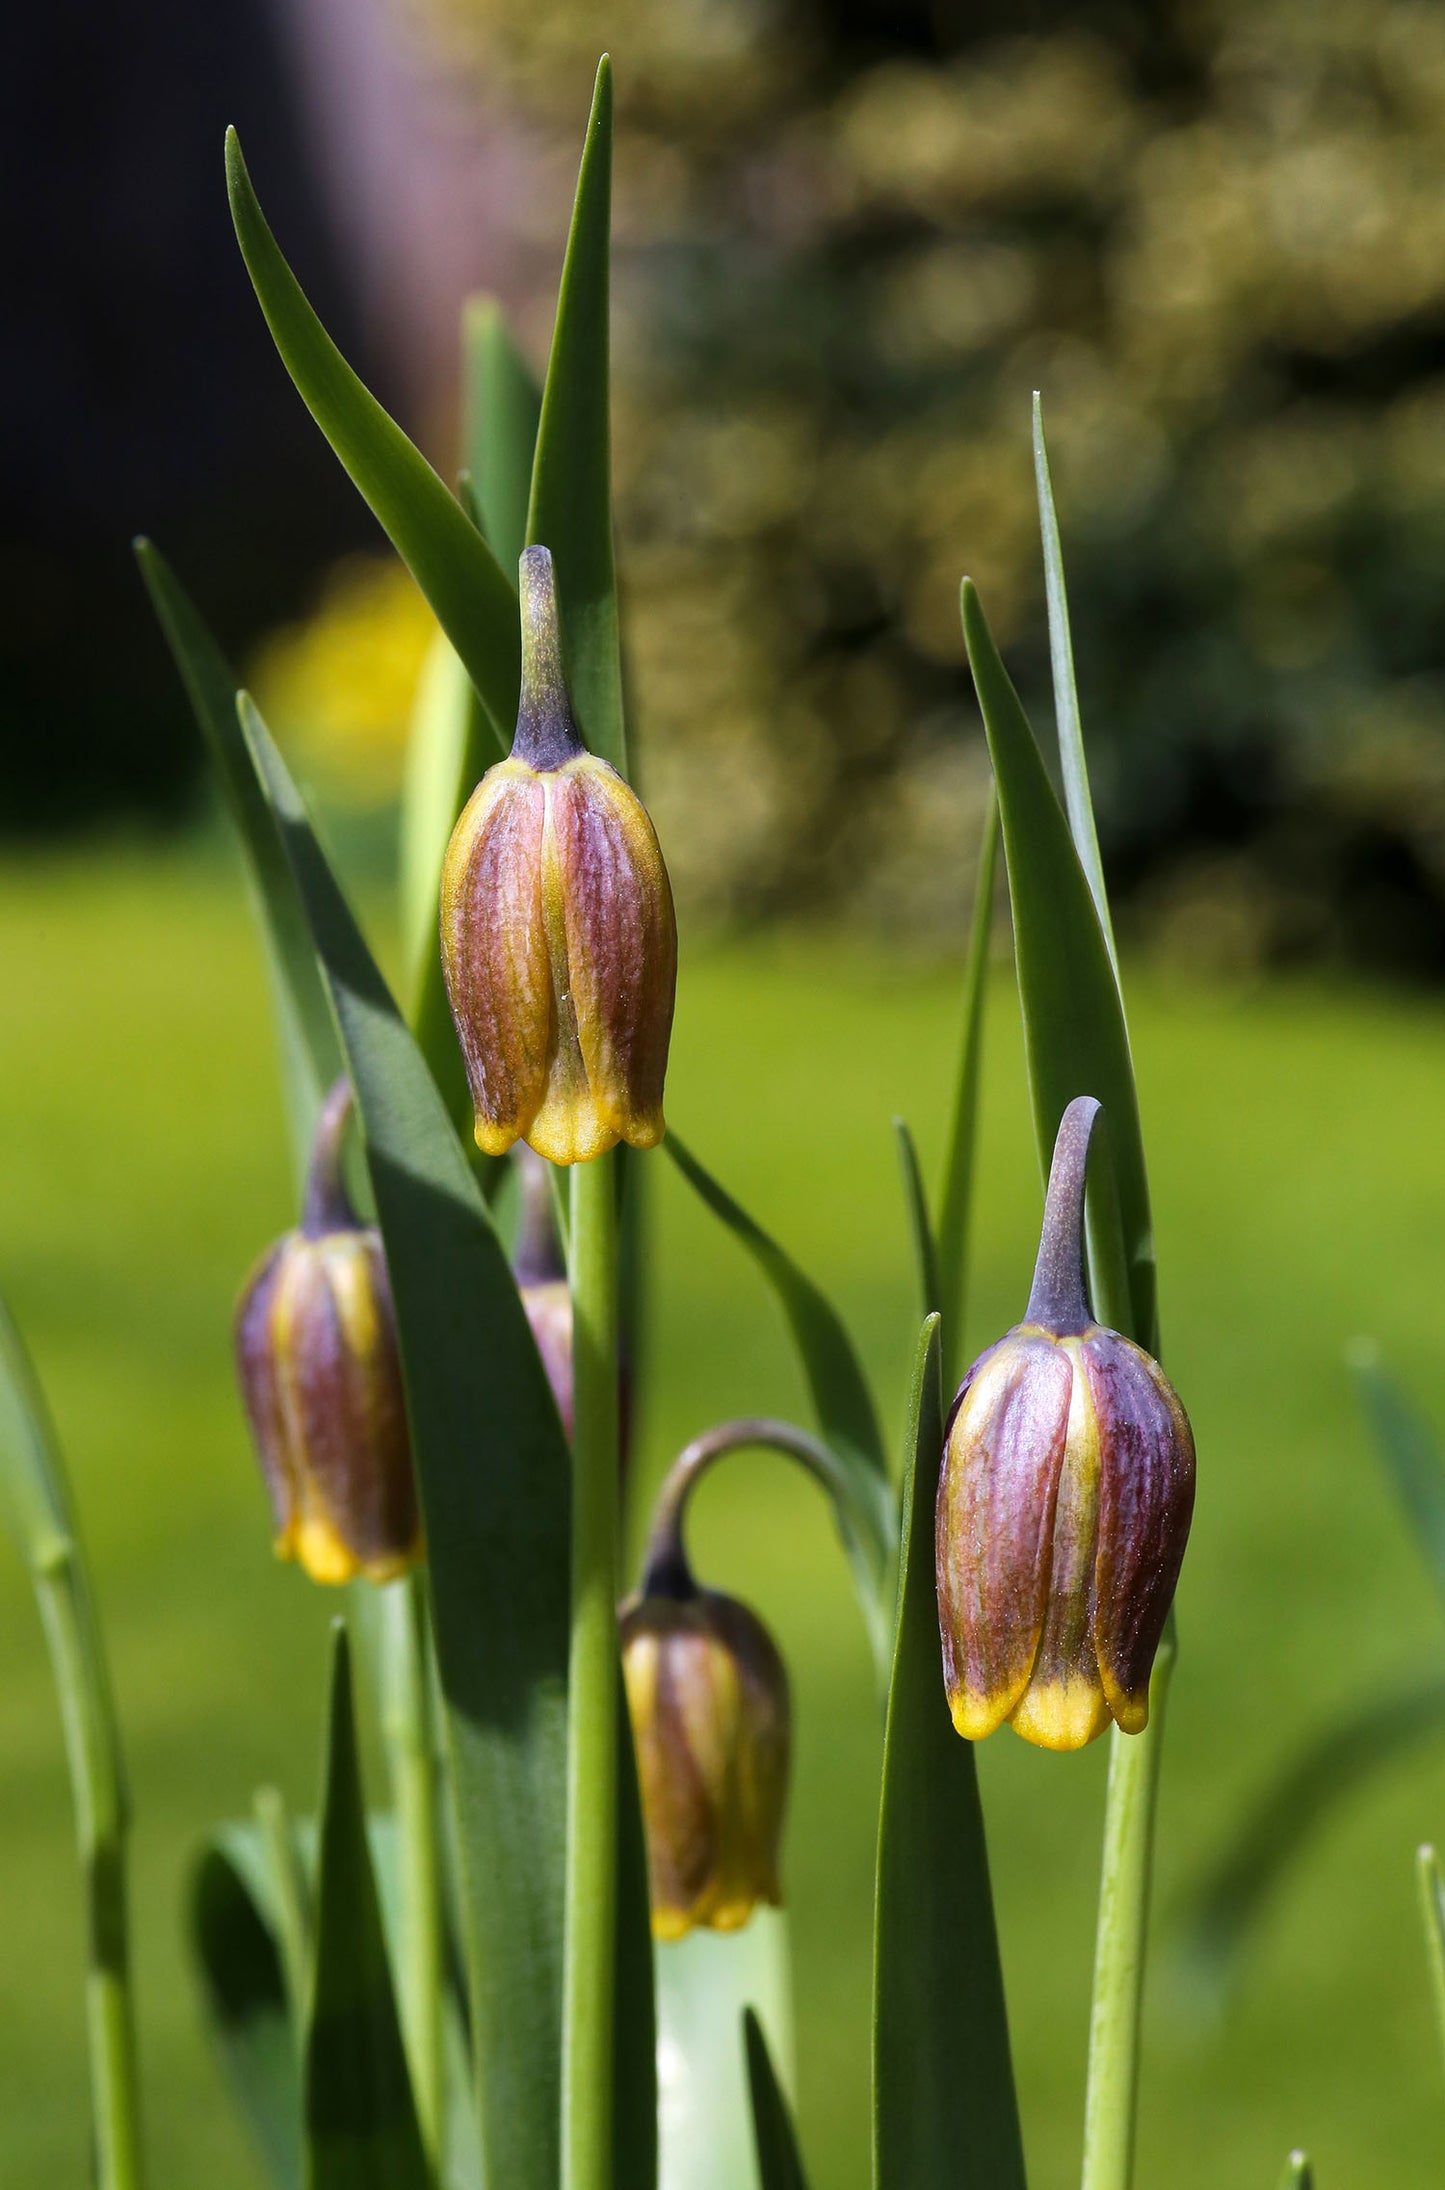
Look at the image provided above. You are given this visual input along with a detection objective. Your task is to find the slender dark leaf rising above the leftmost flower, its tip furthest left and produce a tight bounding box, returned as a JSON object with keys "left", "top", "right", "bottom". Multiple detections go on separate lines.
{"left": 136, "top": 541, "right": 342, "bottom": 1187}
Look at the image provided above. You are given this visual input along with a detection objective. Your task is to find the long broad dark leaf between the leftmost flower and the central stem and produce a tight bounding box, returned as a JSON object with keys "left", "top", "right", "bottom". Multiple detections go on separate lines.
{"left": 241, "top": 703, "right": 571, "bottom": 2190}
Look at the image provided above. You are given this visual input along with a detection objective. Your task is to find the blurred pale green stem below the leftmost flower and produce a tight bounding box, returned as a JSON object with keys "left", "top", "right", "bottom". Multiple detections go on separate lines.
{"left": 381, "top": 1570, "right": 444, "bottom": 2170}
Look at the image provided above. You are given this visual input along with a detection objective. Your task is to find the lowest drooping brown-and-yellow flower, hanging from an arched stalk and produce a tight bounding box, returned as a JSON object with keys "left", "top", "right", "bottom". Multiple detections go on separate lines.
{"left": 620, "top": 1480, "right": 790, "bottom": 1940}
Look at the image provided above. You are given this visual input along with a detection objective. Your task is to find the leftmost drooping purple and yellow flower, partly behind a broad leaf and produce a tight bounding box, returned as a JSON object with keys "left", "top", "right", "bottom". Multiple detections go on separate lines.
{"left": 236, "top": 1080, "right": 420, "bottom": 1581}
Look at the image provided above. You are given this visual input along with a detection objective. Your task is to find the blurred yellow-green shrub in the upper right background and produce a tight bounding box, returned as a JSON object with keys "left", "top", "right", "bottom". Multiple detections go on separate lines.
{"left": 264, "top": 0, "right": 1445, "bottom": 975}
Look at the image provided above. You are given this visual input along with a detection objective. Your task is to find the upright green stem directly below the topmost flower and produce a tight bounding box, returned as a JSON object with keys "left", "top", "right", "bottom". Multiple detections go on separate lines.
{"left": 563, "top": 1156, "right": 620, "bottom": 2190}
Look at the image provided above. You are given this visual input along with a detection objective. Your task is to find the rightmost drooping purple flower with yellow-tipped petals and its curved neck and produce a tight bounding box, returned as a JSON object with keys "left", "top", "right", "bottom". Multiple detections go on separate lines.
{"left": 937, "top": 1097, "right": 1193, "bottom": 1750}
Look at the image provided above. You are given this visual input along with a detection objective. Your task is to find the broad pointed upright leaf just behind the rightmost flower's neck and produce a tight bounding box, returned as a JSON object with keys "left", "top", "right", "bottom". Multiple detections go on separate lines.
{"left": 961, "top": 578, "right": 1158, "bottom": 1353}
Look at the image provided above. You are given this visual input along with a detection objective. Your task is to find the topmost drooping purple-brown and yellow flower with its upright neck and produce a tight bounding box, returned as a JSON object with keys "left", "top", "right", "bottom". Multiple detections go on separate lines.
{"left": 442, "top": 548, "right": 677, "bottom": 1163}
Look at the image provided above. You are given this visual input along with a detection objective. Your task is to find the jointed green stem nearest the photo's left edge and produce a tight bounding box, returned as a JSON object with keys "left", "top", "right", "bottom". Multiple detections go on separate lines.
{"left": 33, "top": 1535, "right": 142, "bottom": 2190}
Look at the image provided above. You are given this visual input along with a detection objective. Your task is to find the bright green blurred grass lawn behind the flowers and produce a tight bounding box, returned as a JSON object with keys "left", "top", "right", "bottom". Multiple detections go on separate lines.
{"left": 0, "top": 832, "right": 1445, "bottom": 2190}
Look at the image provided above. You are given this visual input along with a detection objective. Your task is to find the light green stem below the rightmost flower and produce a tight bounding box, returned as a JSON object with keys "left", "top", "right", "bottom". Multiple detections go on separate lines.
{"left": 1084, "top": 1614, "right": 1178, "bottom": 2190}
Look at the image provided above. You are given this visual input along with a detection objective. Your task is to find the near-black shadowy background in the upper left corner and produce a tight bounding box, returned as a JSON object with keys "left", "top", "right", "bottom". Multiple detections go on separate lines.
{"left": 0, "top": 0, "right": 377, "bottom": 834}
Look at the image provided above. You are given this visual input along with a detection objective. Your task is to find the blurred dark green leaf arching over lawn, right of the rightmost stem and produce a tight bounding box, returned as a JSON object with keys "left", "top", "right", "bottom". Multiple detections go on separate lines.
{"left": 1182, "top": 1675, "right": 1445, "bottom": 1997}
